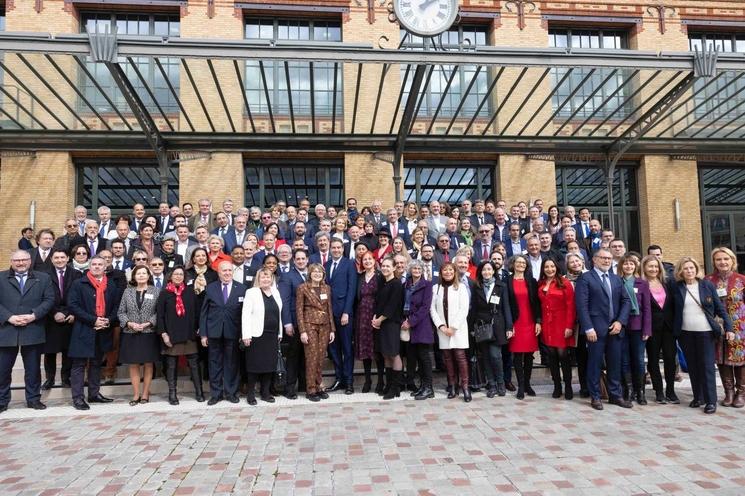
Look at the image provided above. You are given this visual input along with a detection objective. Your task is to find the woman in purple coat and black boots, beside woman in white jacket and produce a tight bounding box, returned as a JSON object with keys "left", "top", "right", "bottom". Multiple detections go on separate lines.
{"left": 401, "top": 260, "right": 435, "bottom": 400}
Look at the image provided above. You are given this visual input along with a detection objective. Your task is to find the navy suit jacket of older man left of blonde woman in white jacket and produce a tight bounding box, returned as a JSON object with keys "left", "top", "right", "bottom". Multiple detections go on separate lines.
{"left": 199, "top": 279, "right": 247, "bottom": 339}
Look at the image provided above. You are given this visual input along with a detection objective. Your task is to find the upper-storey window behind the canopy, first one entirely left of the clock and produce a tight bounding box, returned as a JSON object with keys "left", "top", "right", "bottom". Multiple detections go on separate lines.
{"left": 244, "top": 18, "right": 343, "bottom": 115}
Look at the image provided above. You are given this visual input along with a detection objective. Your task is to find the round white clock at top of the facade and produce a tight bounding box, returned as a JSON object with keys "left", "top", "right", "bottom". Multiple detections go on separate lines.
{"left": 393, "top": 0, "right": 458, "bottom": 37}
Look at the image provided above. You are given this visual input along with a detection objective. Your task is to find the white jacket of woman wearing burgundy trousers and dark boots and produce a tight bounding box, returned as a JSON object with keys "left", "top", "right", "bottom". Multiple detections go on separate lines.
{"left": 429, "top": 284, "right": 471, "bottom": 350}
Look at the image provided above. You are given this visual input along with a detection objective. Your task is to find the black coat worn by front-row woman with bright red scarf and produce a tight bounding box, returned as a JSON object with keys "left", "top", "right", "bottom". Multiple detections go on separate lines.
{"left": 155, "top": 286, "right": 201, "bottom": 344}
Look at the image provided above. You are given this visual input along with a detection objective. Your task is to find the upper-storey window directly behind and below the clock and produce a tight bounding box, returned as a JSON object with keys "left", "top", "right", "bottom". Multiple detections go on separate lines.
{"left": 401, "top": 25, "right": 489, "bottom": 117}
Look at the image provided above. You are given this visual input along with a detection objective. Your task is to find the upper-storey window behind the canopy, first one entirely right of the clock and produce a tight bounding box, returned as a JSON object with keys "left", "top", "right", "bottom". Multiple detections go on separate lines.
{"left": 548, "top": 29, "right": 633, "bottom": 120}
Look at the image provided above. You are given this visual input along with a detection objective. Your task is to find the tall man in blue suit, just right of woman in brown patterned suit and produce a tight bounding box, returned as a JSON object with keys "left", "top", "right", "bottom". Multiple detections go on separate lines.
{"left": 324, "top": 238, "right": 357, "bottom": 394}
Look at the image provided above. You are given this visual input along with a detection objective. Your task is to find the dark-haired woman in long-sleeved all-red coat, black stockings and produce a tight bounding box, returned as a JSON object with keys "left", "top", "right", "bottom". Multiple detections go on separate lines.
{"left": 538, "top": 258, "right": 576, "bottom": 400}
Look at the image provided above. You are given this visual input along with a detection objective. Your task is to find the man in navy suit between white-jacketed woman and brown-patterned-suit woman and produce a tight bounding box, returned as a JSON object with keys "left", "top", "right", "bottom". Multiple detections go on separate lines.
{"left": 277, "top": 250, "right": 308, "bottom": 400}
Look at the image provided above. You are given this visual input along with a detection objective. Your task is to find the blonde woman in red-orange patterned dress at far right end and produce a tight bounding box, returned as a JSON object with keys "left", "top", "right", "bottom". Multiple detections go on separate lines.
{"left": 706, "top": 247, "right": 745, "bottom": 408}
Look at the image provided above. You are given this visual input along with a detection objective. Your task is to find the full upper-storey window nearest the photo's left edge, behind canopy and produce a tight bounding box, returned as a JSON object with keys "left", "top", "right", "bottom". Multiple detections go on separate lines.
{"left": 79, "top": 13, "right": 179, "bottom": 112}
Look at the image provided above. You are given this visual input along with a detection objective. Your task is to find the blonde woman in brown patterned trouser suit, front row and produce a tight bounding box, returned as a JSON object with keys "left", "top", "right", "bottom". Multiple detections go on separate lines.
{"left": 295, "top": 264, "right": 336, "bottom": 401}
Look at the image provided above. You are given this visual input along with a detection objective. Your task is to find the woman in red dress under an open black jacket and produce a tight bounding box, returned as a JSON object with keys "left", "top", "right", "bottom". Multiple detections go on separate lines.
{"left": 507, "top": 255, "right": 541, "bottom": 400}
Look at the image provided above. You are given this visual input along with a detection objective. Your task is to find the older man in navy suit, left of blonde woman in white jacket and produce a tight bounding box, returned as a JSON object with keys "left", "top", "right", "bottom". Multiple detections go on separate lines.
{"left": 198, "top": 261, "right": 246, "bottom": 406}
